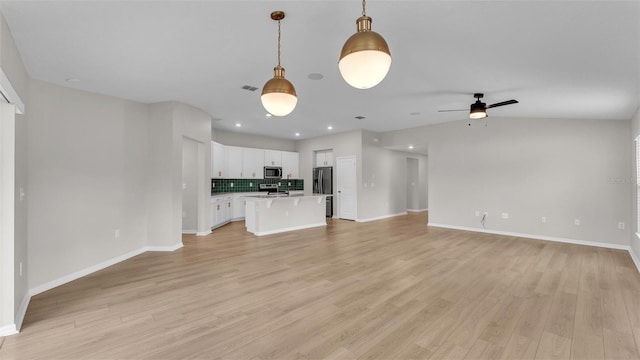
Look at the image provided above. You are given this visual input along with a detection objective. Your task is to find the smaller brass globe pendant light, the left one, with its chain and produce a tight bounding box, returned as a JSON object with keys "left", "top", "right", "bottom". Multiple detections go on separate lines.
{"left": 260, "top": 11, "right": 298, "bottom": 116}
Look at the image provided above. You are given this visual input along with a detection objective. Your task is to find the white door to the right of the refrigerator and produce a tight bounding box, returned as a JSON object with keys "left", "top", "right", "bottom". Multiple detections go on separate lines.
{"left": 336, "top": 155, "right": 358, "bottom": 220}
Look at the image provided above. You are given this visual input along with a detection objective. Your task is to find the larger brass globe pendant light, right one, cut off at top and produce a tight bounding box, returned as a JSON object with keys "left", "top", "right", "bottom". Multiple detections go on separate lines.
{"left": 338, "top": 0, "right": 391, "bottom": 89}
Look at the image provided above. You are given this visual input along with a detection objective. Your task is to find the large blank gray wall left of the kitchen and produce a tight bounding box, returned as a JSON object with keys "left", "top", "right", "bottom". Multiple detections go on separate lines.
{"left": 27, "top": 80, "right": 155, "bottom": 288}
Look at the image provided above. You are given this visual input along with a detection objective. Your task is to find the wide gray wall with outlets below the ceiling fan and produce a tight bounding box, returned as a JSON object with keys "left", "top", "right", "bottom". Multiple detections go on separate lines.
{"left": 384, "top": 118, "right": 631, "bottom": 246}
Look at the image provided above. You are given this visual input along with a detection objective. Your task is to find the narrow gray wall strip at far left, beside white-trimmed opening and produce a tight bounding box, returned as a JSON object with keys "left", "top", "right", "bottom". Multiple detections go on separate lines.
{"left": 0, "top": 9, "right": 30, "bottom": 328}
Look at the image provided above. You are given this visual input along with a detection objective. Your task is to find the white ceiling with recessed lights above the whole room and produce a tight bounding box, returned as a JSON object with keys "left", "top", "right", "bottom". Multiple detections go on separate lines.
{"left": 0, "top": 0, "right": 640, "bottom": 139}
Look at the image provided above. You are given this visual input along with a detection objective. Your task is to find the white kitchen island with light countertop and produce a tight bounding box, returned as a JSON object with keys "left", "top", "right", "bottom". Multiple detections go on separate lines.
{"left": 245, "top": 195, "right": 331, "bottom": 236}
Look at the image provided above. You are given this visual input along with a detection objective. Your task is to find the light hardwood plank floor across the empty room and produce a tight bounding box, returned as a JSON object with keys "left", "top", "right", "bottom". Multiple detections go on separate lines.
{"left": 0, "top": 213, "right": 640, "bottom": 360}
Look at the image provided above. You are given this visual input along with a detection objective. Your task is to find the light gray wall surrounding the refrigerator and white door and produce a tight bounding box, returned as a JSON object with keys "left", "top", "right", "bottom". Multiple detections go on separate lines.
{"left": 294, "top": 130, "right": 362, "bottom": 216}
